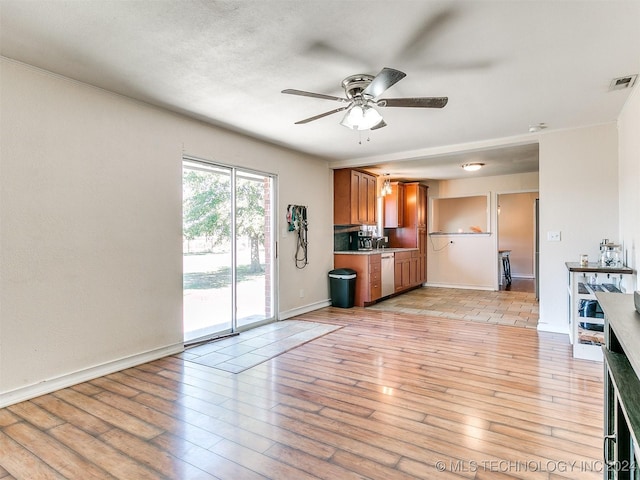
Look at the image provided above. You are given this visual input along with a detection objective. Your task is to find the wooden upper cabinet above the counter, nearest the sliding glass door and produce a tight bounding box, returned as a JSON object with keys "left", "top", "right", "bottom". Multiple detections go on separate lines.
{"left": 333, "top": 168, "right": 377, "bottom": 225}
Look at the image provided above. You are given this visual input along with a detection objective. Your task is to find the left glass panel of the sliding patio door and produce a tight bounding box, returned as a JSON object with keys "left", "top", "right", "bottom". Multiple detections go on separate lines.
{"left": 182, "top": 161, "right": 233, "bottom": 342}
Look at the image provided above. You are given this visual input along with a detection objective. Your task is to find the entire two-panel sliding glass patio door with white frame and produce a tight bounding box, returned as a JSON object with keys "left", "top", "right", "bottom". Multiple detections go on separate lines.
{"left": 182, "top": 158, "right": 275, "bottom": 343}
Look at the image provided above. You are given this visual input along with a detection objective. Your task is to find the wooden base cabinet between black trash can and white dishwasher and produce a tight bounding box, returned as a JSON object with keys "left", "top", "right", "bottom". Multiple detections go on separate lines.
{"left": 333, "top": 253, "right": 382, "bottom": 307}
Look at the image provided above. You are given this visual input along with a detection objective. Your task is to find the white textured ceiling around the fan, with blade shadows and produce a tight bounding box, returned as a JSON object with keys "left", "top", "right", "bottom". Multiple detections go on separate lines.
{"left": 0, "top": 0, "right": 640, "bottom": 178}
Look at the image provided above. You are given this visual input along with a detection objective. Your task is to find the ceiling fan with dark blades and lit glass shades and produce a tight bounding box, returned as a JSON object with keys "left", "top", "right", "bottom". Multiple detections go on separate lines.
{"left": 282, "top": 67, "right": 449, "bottom": 130}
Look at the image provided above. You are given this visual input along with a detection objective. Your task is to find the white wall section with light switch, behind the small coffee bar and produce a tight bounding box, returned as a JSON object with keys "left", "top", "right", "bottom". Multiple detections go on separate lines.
{"left": 538, "top": 123, "right": 619, "bottom": 334}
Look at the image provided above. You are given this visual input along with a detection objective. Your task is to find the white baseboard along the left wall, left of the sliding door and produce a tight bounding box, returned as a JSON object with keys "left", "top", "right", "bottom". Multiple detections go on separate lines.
{"left": 0, "top": 343, "right": 184, "bottom": 408}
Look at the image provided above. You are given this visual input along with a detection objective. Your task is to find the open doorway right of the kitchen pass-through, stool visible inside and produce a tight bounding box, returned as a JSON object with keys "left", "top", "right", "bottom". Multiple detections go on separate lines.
{"left": 497, "top": 192, "right": 539, "bottom": 292}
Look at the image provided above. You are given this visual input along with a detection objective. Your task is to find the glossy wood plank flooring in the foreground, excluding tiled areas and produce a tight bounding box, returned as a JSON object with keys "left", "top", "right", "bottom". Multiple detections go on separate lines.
{"left": 0, "top": 307, "right": 603, "bottom": 480}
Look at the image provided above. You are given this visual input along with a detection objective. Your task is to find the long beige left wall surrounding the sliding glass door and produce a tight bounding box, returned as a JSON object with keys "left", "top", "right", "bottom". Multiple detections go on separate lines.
{"left": 0, "top": 59, "right": 333, "bottom": 406}
